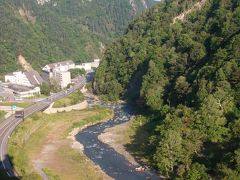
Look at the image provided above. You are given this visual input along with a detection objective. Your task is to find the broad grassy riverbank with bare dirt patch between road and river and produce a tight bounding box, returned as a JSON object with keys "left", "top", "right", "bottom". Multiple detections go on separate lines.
{"left": 9, "top": 108, "right": 112, "bottom": 179}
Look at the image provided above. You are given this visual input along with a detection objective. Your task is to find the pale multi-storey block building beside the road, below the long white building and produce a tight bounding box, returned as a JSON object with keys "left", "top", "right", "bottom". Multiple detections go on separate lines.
{"left": 52, "top": 71, "right": 71, "bottom": 88}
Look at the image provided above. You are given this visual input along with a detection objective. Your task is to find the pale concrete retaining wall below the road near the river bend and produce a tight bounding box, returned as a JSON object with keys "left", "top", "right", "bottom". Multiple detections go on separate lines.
{"left": 44, "top": 100, "right": 88, "bottom": 114}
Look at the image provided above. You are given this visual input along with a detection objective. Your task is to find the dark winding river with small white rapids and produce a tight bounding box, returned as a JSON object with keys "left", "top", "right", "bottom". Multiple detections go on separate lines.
{"left": 76, "top": 100, "right": 160, "bottom": 180}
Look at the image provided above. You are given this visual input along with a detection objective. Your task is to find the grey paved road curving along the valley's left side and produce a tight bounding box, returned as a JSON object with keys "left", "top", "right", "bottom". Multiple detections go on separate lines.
{"left": 0, "top": 78, "right": 86, "bottom": 176}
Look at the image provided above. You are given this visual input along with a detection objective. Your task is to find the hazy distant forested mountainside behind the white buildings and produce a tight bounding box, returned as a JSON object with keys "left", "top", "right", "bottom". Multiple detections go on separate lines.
{"left": 0, "top": 0, "right": 154, "bottom": 73}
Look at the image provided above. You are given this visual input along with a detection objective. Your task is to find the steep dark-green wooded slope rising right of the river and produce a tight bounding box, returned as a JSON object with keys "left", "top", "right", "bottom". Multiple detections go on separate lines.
{"left": 94, "top": 0, "right": 240, "bottom": 180}
